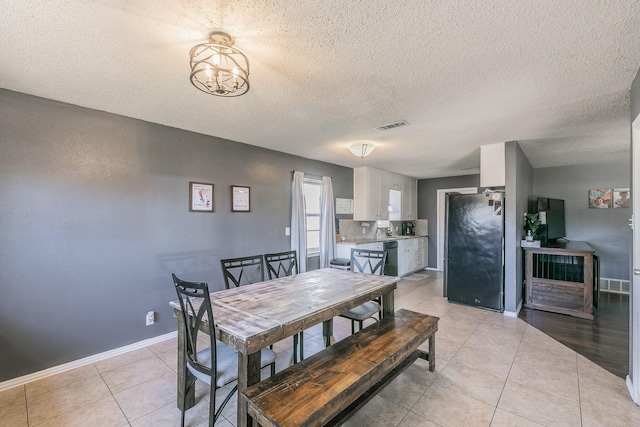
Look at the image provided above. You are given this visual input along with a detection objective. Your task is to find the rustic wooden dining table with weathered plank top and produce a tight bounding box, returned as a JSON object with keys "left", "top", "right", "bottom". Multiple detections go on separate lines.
{"left": 170, "top": 268, "right": 400, "bottom": 427}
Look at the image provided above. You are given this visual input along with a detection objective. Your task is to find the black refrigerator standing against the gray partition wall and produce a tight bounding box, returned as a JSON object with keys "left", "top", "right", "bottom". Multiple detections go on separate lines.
{"left": 444, "top": 192, "right": 504, "bottom": 312}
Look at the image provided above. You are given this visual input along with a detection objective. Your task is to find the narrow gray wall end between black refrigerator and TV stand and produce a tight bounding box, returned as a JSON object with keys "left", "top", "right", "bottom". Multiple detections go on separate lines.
{"left": 504, "top": 141, "right": 533, "bottom": 313}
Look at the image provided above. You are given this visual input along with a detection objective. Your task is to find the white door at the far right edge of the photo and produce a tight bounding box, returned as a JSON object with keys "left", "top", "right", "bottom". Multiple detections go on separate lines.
{"left": 627, "top": 115, "right": 640, "bottom": 405}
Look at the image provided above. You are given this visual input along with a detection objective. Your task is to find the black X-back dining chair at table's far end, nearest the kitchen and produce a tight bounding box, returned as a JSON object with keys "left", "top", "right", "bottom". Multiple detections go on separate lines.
{"left": 340, "top": 248, "right": 387, "bottom": 334}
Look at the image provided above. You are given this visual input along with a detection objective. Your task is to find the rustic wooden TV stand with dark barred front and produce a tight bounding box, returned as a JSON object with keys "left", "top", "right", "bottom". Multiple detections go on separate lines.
{"left": 523, "top": 242, "right": 600, "bottom": 319}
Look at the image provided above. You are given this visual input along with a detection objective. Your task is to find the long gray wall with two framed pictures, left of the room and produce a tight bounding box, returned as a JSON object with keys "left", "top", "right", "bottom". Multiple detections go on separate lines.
{"left": 0, "top": 90, "right": 353, "bottom": 381}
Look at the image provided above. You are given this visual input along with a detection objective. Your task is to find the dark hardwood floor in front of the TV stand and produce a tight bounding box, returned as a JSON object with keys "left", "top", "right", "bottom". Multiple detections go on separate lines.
{"left": 518, "top": 293, "right": 629, "bottom": 378}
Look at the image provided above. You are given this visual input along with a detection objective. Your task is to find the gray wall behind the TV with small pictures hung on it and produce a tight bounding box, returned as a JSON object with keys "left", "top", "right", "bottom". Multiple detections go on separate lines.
{"left": 533, "top": 161, "right": 636, "bottom": 280}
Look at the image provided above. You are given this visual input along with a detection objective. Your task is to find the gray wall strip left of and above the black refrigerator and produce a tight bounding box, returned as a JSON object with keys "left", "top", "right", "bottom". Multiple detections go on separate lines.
{"left": 418, "top": 175, "right": 480, "bottom": 268}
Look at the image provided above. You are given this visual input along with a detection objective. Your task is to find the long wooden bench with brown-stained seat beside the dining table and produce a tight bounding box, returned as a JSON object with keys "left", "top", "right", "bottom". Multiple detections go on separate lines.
{"left": 243, "top": 310, "right": 439, "bottom": 427}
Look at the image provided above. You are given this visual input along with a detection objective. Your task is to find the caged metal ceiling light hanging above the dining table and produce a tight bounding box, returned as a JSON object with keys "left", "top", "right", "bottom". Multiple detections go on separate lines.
{"left": 189, "top": 31, "right": 249, "bottom": 97}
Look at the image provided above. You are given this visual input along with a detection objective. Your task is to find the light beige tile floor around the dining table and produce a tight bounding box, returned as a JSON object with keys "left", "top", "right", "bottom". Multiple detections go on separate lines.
{"left": 0, "top": 271, "right": 640, "bottom": 427}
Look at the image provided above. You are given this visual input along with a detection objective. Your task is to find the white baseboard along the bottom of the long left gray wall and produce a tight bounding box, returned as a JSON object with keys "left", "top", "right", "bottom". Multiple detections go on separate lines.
{"left": 0, "top": 331, "right": 178, "bottom": 391}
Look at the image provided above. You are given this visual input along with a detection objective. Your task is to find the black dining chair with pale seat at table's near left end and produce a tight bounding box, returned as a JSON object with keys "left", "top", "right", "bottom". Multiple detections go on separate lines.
{"left": 171, "top": 274, "right": 276, "bottom": 427}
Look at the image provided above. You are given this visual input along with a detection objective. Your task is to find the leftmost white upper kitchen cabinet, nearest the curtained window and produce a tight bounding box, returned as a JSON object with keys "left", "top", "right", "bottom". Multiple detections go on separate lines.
{"left": 353, "top": 167, "right": 389, "bottom": 221}
